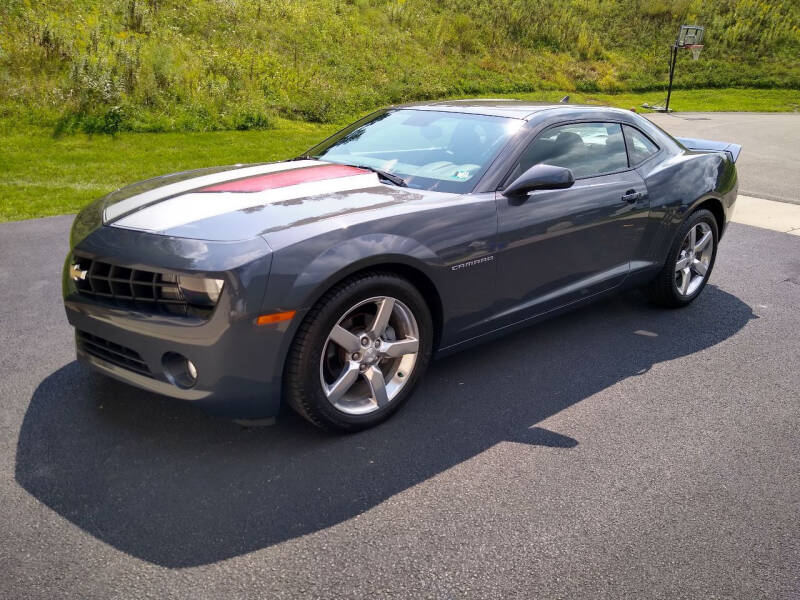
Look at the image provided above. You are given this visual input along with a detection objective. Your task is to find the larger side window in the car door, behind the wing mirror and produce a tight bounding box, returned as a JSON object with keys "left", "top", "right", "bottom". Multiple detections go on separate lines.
{"left": 511, "top": 123, "right": 628, "bottom": 180}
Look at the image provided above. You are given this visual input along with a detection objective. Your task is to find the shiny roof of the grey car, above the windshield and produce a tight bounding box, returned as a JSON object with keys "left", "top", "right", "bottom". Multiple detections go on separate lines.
{"left": 395, "top": 98, "right": 628, "bottom": 120}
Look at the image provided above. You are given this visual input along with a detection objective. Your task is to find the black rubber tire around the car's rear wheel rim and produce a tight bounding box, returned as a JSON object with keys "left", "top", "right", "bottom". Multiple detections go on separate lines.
{"left": 644, "top": 209, "right": 719, "bottom": 308}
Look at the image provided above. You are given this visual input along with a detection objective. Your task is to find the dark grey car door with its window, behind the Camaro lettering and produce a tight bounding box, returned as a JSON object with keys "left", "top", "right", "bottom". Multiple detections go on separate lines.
{"left": 497, "top": 123, "right": 649, "bottom": 325}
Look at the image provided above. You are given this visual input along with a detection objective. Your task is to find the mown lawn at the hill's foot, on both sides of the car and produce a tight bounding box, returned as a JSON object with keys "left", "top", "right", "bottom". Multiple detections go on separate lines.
{"left": 0, "top": 89, "right": 800, "bottom": 221}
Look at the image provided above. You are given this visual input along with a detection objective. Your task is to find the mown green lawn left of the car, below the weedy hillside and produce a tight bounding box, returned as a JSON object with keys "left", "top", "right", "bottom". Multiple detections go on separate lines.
{"left": 0, "top": 121, "right": 336, "bottom": 221}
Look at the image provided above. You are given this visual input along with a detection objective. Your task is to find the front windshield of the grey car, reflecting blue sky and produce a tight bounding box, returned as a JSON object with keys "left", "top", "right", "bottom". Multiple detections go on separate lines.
{"left": 308, "top": 109, "right": 523, "bottom": 193}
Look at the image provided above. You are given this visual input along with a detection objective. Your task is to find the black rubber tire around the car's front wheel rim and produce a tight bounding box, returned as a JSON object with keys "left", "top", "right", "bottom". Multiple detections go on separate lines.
{"left": 284, "top": 272, "right": 433, "bottom": 432}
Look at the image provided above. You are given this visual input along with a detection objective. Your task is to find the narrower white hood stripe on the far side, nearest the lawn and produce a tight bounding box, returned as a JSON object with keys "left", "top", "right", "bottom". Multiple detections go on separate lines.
{"left": 103, "top": 160, "right": 328, "bottom": 223}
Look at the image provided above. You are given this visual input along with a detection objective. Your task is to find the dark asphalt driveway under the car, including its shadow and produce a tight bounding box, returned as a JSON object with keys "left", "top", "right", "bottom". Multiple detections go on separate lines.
{"left": 0, "top": 217, "right": 800, "bottom": 600}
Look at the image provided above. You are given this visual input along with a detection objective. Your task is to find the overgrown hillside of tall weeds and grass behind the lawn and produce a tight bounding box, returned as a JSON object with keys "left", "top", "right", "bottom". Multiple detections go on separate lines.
{"left": 0, "top": 0, "right": 800, "bottom": 132}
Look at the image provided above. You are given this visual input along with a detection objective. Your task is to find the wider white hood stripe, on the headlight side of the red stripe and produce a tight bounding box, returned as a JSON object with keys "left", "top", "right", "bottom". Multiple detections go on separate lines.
{"left": 114, "top": 173, "right": 379, "bottom": 232}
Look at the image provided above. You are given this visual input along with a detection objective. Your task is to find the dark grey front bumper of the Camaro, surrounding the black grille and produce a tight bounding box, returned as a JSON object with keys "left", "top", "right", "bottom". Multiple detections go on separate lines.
{"left": 63, "top": 227, "right": 289, "bottom": 419}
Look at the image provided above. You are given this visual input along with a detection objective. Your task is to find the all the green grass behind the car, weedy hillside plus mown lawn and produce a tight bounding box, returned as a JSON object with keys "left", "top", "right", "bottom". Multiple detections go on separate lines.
{"left": 0, "top": 0, "right": 800, "bottom": 221}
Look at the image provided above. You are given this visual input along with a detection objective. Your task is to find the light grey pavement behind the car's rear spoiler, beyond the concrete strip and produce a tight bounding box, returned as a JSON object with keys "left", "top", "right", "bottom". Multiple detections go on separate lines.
{"left": 647, "top": 113, "right": 800, "bottom": 204}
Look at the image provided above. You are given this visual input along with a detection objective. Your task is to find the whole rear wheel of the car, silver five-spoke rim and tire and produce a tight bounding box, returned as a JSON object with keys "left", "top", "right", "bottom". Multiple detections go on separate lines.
{"left": 645, "top": 209, "right": 719, "bottom": 308}
